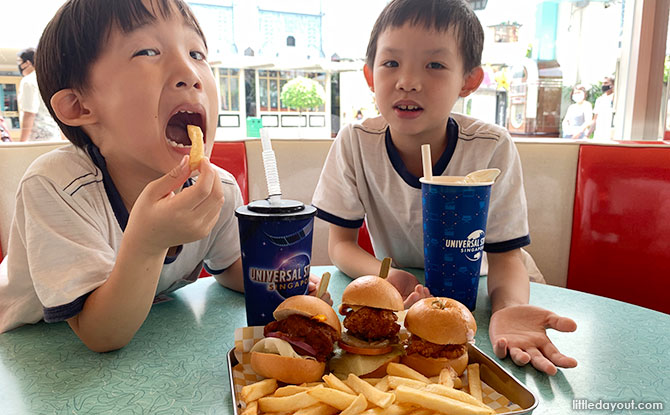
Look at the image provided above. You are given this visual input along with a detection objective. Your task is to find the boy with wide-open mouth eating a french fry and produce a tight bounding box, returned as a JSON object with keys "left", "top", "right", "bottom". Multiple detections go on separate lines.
{"left": 0, "top": 0, "right": 329, "bottom": 351}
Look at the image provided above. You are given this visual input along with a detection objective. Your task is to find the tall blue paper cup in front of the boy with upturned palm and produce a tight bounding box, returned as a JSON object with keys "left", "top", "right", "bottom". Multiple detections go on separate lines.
{"left": 421, "top": 176, "right": 493, "bottom": 310}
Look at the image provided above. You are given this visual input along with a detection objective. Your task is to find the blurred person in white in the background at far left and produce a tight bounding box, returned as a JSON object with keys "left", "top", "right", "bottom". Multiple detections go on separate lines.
{"left": 17, "top": 48, "right": 60, "bottom": 141}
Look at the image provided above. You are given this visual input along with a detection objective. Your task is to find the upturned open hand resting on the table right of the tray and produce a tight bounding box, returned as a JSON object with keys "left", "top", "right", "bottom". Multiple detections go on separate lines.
{"left": 489, "top": 305, "right": 577, "bottom": 376}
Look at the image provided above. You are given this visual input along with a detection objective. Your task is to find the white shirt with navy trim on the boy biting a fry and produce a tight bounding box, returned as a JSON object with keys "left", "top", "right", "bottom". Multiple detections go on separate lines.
{"left": 0, "top": 145, "right": 243, "bottom": 333}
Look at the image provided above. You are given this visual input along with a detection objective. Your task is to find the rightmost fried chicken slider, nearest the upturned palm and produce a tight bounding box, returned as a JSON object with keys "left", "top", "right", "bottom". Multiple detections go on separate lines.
{"left": 401, "top": 297, "right": 477, "bottom": 377}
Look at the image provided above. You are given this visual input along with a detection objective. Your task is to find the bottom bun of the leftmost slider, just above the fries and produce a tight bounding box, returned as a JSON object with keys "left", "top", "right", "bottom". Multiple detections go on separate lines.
{"left": 251, "top": 352, "right": 326, "bottom": 385}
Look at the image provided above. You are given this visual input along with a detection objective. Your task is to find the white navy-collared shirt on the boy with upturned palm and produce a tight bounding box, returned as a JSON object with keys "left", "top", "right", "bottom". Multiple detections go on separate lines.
{"left": 312, "top": 114, "right": 530, "bottom": 268}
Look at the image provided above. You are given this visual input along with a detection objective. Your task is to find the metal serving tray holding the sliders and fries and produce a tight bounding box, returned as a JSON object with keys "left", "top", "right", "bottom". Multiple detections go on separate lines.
{"left": 228, "top": 344, "right": 538, "bottom": 415}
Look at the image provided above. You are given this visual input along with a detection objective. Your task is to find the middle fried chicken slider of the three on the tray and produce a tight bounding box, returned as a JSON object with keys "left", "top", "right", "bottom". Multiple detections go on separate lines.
{"left": 330, "top": 275, "right": 404, "bottom": 377}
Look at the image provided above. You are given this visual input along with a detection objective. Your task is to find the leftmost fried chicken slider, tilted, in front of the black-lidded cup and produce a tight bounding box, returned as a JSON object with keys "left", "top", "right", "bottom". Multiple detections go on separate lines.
{"left": 251, "top": 295, "right": 342, "bottom": 384}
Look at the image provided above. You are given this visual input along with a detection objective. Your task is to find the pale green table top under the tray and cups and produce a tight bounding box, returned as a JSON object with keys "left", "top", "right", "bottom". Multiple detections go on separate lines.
{"left": 0, "top": 267, "right": 670, "bottom": 415}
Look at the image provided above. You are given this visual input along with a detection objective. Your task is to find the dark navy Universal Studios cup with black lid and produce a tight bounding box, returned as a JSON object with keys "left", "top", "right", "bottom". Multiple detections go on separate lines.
{"left": 235, "top": 200, "right": 316, "bottom": 326}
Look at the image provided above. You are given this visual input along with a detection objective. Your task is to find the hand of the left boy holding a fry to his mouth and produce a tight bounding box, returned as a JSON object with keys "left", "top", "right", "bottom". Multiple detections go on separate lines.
{"left": 126, "top": 156, "right": 224, "bottom": 254}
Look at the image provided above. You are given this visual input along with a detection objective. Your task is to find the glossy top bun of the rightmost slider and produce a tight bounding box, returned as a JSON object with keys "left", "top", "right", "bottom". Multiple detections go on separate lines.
{"left": 405, "top": 297, "right": 477, "bottom": 344}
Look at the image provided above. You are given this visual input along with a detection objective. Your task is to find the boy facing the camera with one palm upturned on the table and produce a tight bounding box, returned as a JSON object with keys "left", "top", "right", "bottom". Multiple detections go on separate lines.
{"left": 313, "top": 0, "right": 576, "bottom": 374}
